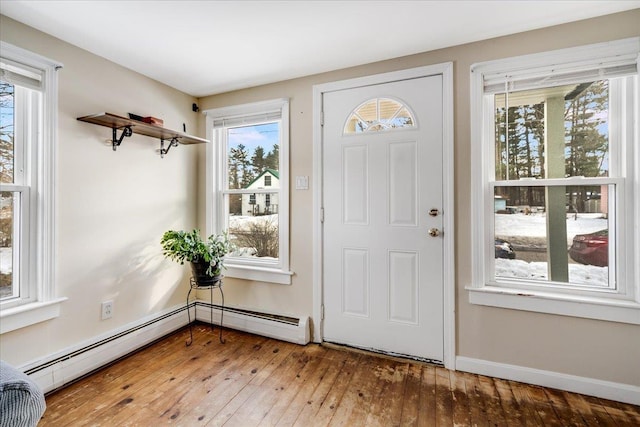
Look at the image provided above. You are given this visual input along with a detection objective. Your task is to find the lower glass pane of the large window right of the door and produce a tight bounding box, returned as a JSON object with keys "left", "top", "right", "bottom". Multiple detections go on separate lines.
{"left": 494, "top": 186, "right": 614, "bottom": 287}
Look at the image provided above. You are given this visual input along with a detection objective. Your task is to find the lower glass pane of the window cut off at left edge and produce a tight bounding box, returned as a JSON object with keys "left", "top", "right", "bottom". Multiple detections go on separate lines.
{"left": 0, "top": 191, "right": 17, "bottom": 299}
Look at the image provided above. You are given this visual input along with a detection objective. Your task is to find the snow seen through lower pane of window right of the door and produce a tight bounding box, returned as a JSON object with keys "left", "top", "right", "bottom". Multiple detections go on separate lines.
{"left": 495, "top": 213, "right": 609, "bottom": 286}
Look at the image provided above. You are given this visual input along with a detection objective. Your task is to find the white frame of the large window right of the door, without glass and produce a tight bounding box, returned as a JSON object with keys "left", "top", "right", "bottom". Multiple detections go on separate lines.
{"left": 466, "top": 37, "right": 640, "bottom": 324}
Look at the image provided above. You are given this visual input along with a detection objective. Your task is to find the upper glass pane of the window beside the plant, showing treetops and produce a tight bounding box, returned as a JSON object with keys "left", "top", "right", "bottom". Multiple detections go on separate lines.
{"left": 227, "top": 122, "right": 280, "bottom": 189}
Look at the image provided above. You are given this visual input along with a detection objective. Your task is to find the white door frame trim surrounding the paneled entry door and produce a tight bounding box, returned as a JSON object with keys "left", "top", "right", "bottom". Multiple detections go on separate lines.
{"left": 312, "top": 62, "right": 456, "bottom": 369}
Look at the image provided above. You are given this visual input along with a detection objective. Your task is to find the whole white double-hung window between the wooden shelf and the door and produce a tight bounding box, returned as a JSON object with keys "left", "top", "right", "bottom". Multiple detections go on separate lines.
{"left": 205, "top": 99, "right": 292, "bottom": 284}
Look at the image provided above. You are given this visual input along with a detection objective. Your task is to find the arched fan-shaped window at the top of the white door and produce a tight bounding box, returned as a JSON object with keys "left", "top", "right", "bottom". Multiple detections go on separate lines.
{"left": 343, "top": 98, "right": 416, "bottom": 135}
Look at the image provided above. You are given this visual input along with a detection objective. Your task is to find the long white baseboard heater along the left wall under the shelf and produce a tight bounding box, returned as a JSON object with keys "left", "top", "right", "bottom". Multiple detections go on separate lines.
{"left": 19, "top": 306, "right": 187, "bottom": 393}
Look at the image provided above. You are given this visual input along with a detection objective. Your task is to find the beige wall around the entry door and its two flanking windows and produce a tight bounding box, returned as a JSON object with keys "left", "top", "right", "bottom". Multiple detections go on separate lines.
{"left": 198, "top": 9, "right": 640, "bottom": 385}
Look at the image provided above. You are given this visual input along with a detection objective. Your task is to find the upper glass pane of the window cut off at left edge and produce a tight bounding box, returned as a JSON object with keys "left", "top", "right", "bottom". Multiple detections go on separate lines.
{"left": 0, "top": 81, "right": 15, "bottom": 183}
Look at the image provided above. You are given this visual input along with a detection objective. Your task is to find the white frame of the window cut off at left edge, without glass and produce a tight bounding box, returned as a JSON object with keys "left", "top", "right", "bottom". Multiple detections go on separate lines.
{"left": 0, "top": 41, "right": 66, "bottom": 334}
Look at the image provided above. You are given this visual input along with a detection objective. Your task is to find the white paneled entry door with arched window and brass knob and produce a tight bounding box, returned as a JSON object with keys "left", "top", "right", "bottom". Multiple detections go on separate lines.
{"left": 322, "top": 75, "right": 444, "bottom": 361}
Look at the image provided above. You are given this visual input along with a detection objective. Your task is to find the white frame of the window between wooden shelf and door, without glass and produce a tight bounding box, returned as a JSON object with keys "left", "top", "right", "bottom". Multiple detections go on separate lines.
{"left": 204, "top": 99, "right": 293, "bottom": 285}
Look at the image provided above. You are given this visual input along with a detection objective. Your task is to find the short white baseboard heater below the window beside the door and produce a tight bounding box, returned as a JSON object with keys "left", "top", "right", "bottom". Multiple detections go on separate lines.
{"left": 195, "top": 301, "right": 311, "bottom": 345}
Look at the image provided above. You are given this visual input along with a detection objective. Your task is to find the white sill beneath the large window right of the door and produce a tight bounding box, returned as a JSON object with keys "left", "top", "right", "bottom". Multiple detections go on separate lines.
{"left": 466, "top": 286, "right": 640, "bottom": 325}
